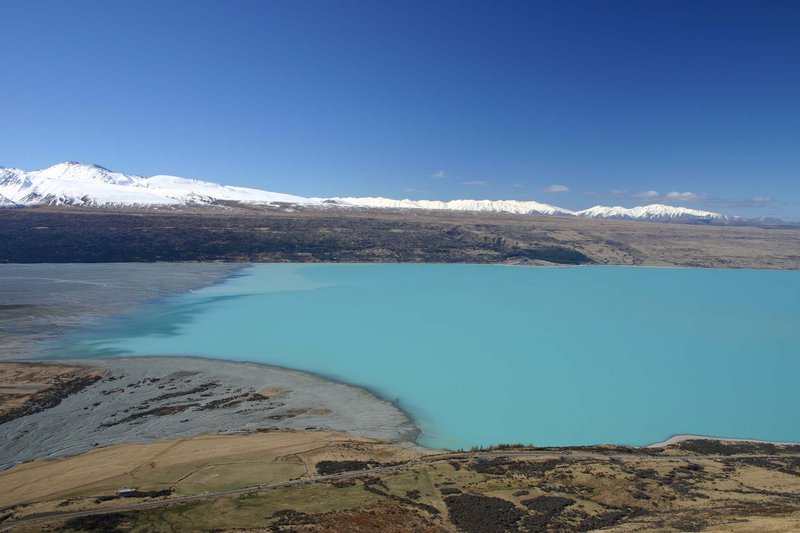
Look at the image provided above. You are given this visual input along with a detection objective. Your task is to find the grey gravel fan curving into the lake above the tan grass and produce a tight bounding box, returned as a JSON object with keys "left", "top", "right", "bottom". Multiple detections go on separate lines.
{"left": 0, "top": 357, "right": 418, "bottom": 469}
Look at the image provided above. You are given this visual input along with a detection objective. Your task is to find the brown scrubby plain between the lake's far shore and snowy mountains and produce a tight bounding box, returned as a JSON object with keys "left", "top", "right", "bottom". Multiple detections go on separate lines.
{"left": 0, "top": 204, "right": 800, "bottom": 269}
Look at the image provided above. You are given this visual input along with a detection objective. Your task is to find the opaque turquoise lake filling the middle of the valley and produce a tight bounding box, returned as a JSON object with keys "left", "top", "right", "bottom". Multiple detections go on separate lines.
{"left": 54, "top": 264, "right": 800, "bottom": 448}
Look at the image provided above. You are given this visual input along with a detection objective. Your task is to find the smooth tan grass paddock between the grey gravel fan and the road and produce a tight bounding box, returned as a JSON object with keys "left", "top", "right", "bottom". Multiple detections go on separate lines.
{"left": 0, "top": 431, "right": 416, "bottom": 513}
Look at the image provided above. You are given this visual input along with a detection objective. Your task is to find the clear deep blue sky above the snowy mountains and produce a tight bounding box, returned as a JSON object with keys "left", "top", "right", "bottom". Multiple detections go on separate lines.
{"left": 0, "top": 0, "right": 800, "bottom": 220}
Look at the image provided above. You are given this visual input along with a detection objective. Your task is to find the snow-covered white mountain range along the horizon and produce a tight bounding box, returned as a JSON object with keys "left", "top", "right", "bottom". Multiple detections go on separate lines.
{"left": 0, "top": 162, "right": 782, "bottom": 224}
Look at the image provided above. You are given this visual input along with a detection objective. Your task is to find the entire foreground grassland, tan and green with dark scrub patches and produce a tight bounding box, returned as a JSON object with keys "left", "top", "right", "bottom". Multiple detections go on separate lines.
{"left": 0, "top": 432, "right": 800, "bottom": 533}
